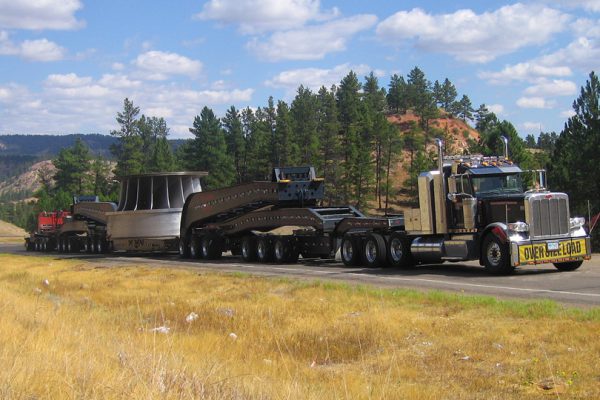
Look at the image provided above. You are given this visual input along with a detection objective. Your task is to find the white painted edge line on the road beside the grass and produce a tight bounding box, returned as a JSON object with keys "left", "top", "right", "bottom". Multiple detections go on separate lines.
{"left": 226, "top": 264, "right": 600, "bottom": 297}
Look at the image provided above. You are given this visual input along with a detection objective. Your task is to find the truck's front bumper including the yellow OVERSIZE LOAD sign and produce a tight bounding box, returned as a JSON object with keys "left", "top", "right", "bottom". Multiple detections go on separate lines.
{"left": 510, "top": 236, "right": 592, "bottom": 267}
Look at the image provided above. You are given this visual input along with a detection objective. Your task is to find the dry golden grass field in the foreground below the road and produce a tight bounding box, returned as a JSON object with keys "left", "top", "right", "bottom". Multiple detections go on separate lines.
{"left": 0, "top": 255, "right": 600, "bottom": 399}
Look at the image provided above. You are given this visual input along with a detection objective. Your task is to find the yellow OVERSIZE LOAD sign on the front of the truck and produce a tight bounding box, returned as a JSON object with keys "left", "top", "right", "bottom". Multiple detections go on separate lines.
{"left": 519, "top": 239, "right": 587, "bottom": 263}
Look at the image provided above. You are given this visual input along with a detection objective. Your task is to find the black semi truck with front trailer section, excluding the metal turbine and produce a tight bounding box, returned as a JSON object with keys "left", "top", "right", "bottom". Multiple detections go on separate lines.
{"left": 179, "top": 139, "right": 591, "bottom": 274}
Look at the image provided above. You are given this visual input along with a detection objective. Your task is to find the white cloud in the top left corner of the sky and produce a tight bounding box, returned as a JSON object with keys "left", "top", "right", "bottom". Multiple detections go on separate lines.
{"left": 0, "top": 0, "right": 84, "bottom": 30}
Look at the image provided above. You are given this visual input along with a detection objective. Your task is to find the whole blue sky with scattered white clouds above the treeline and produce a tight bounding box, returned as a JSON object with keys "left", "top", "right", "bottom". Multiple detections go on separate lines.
{"left": 0, "top": 0, "right": 600, "bottom": 138}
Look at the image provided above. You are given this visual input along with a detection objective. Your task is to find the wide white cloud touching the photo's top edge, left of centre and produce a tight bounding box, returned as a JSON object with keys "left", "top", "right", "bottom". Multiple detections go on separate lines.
{"left": 196, "top": 0, "right": 338, "bottom": 34}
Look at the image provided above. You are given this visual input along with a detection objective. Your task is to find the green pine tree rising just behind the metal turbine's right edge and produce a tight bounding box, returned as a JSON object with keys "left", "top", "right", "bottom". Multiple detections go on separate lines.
{"left": 186, "top": 107, "right": 235, "bottom": 189}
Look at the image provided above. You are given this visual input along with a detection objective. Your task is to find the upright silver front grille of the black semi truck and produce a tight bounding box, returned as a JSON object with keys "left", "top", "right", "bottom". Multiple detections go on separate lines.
{"left": 525, "top": 193, "right": 569, "bottom": 239}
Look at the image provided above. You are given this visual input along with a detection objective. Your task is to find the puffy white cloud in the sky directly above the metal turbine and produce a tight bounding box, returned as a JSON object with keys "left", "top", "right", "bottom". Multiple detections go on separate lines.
{"left": 133, "top": 50, "right": 202, "bottom": 81}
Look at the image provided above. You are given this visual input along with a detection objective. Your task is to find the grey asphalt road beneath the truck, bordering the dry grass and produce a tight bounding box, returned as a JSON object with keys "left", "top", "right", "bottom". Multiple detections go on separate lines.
{"left": 0, "top": 244, "right": 600, "bottom": 307}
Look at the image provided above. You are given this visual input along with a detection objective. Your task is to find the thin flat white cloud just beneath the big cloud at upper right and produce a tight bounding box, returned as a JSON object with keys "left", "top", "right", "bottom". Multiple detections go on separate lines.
{"left": 478, "top": 60, "right": 572, "bottom": 84}
